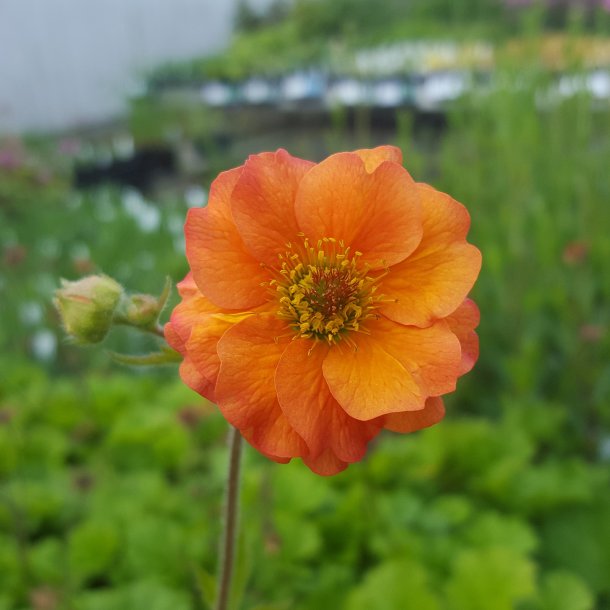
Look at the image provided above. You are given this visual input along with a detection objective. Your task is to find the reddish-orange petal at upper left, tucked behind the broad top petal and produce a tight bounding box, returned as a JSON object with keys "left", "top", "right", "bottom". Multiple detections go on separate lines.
{"left": 231, "top": 149, "right": 314, "bottom": 265}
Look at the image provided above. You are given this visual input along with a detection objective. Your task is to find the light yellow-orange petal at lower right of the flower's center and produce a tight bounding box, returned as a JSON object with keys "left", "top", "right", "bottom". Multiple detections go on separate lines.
{"left": 322, "top": 318, "right": 461, "bottom": 420}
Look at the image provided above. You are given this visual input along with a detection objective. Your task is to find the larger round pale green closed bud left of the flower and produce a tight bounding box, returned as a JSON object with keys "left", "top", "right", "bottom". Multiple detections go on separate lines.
{"left": 54, "top": 275, "right": 123, "bottom": 343}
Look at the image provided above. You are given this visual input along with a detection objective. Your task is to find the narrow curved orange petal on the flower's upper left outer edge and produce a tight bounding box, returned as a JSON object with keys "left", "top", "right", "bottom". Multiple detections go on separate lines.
{"left": 184, "top": 168, "right": 269, "bottom": 310}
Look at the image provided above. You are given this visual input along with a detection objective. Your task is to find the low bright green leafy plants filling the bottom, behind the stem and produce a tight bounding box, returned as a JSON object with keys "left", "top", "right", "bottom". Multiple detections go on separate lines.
{"left": 0, "top": 359, "right": 610, "bottom": 610}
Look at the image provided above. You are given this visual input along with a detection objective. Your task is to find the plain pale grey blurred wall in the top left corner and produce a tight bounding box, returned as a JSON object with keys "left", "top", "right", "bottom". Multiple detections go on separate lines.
{"left": 0, "top": 0, "right": 235, "bottom": 133}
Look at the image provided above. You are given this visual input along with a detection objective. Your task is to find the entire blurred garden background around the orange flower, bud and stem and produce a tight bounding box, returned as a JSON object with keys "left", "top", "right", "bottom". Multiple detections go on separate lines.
{"left": 0, "top": 0, "right": 610, "bottom": 610}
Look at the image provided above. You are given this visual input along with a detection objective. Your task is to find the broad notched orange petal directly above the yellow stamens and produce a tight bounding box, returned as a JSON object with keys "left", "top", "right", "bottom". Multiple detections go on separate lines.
{"left": 295, "top": 153, "right": 422, "bottom": 269}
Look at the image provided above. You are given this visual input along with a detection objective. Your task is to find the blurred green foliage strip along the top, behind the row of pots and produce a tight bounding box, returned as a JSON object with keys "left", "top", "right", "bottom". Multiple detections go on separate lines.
{"left": 149, "top": 0, "right": 610, "bottom": 82}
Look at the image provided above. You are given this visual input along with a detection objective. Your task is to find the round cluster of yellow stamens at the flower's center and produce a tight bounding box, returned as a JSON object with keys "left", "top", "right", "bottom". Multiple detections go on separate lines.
{"left": 271, "top": 237, "right": 379, "bottom": 344}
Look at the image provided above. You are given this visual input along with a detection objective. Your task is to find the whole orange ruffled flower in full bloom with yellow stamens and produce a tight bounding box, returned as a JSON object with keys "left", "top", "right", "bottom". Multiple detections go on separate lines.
{"left": 165, "top": 146, "right": 481, "bottom": 475}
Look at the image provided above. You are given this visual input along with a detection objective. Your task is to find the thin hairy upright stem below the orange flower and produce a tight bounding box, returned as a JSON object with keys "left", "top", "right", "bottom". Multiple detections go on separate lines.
{"left": 215, "top": 426, "right": 242, "bottom": 610}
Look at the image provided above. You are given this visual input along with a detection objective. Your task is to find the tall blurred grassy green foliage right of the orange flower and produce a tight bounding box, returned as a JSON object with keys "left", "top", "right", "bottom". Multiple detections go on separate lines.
{"left": 432, "top": 68, "right": 610, "bottom": 436}
